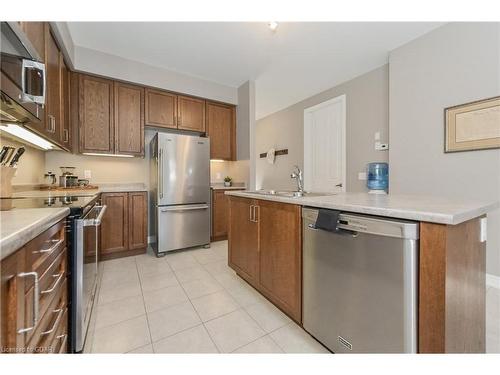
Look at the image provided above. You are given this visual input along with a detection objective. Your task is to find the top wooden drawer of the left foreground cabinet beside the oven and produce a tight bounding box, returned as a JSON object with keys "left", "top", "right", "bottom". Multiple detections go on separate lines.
{"left": 26, "top": 220, "right": 66, "bottom": 280}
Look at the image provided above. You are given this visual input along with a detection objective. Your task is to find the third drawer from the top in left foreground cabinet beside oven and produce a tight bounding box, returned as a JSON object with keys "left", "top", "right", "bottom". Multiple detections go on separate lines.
{"left": 27, "top": 278, "right": 68, "bottom": 353}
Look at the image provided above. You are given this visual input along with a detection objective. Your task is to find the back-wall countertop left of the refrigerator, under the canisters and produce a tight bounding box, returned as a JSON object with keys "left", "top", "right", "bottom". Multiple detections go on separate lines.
{"left": 13, "top": 183, "right": 147, "bottom": 197}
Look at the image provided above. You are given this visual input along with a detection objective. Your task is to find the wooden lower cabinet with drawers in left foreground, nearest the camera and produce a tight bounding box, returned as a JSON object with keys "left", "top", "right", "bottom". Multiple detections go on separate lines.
{"left": 0, "top": 219, "right": 68, "bottom": 353}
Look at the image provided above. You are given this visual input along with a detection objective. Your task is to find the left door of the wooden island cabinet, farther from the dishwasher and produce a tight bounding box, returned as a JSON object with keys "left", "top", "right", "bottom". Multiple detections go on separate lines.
{"left": 229, "top": 197, "right": 259, "bottom": 285}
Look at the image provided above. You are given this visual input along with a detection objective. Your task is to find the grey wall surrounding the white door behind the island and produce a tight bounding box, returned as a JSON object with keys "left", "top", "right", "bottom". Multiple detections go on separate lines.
{"left": 255, "top": 65, "right": 389, "bottom": 192}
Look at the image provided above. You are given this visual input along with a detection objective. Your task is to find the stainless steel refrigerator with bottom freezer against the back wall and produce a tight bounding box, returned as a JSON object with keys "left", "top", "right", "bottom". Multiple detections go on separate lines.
{"left": 150, "top": 133, "right": 210, "bottom": 256}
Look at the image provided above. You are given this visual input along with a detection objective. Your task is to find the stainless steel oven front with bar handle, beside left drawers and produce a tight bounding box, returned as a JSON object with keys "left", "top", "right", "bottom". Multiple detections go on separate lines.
{"left": 72, "top": 204, "right": 106, "bottom": 352}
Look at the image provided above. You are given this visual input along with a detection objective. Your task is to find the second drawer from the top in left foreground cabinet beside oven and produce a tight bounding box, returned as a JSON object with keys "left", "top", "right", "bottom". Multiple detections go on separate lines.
{"left": 24, "top": 249, "right": 66, "bottom": 340}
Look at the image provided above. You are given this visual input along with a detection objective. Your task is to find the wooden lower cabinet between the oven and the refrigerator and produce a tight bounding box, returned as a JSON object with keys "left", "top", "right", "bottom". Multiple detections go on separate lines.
{"left": 100, "top": 192, "right": 148, "bottom": 260}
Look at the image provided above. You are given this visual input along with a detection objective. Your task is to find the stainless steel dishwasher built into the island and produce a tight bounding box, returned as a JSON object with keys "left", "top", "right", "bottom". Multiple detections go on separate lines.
{"left": 302, "top": 208, "right": 418, "bottom": 353}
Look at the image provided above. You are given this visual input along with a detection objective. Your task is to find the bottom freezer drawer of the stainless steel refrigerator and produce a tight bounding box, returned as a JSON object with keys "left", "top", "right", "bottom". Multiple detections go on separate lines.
{"left": 155, "top": 204, "right": 210, "bottom": 253}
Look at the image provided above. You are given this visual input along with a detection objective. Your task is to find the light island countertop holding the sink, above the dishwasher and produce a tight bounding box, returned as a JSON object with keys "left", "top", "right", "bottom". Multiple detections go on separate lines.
{"left": 225, "top": 191, "right": 500, "bottom": 225}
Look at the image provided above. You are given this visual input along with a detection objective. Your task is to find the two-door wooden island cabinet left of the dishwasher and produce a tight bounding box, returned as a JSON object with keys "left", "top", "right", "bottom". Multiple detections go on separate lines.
{"left": 229, "top": 196, "right": 302, "bottom": 323}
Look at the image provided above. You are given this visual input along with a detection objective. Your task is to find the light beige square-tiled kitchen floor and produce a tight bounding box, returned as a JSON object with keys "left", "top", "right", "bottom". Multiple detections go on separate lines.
{"left": 85, "top": 241, "right": 500, "bottom": 353}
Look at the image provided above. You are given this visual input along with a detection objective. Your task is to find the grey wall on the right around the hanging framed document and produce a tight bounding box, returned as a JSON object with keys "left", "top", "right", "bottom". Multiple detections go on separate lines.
{"left": 389, "top": 23, "right": 500, "bottom": 276}
